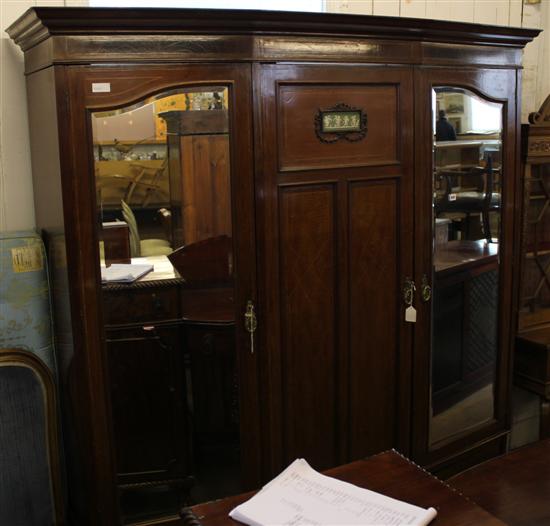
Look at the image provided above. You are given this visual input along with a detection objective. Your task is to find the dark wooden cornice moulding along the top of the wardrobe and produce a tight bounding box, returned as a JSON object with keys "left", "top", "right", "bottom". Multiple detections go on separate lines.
{"left": 6, "top": 7, "right": 540, "bottom": 51}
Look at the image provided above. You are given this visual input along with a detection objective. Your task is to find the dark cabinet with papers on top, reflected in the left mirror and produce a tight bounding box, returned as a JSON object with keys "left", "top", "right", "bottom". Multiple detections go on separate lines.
{"left": 102, "top": 256, "right": 194, "bottom": 520}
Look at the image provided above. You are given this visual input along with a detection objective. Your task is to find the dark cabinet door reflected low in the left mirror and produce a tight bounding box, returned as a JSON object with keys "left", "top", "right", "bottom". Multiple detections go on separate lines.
{"left": 107, "top": 328, "right": 190, "bottom": 482}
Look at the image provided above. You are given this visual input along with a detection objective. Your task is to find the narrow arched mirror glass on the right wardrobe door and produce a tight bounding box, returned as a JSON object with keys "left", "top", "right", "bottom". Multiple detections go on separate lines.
{"left": 430, "top": 86, "right": 503, "bottom": 449}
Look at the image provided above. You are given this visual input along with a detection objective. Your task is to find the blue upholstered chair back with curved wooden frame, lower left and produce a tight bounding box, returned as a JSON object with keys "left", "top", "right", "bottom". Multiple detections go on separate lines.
{"left": 0, "top": 349, "right": 64, "bottom": 526}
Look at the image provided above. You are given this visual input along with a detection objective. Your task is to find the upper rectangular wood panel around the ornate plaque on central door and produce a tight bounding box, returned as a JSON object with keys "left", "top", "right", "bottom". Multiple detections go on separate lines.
{"left": 277, "top": 84, "right": 399, "bottom": 171}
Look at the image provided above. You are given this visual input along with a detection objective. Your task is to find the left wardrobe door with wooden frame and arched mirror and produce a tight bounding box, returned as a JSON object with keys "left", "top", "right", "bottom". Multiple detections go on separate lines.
{"left": 80, "top": 65, "right": 260, "bottom": 523}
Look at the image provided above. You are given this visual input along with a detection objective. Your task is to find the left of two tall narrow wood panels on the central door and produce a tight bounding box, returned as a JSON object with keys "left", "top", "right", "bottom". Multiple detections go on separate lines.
{"left": 279, "top": 185, "right": 336, "bottom": 468}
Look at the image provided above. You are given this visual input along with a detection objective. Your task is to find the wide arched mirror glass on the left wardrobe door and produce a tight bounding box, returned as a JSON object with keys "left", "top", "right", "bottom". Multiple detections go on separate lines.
{"left": 91, "top": 85, "right": 241, "bottom": 523}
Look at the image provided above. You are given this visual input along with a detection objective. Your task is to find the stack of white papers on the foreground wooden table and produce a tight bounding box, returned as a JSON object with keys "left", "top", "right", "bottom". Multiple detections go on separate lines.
{"left": 229, "top": 459, "right": 437, "bottom": 526}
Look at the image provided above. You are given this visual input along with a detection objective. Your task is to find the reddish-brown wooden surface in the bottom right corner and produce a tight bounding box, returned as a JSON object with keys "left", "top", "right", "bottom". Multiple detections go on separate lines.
{"left": 447, "top": 440, "right": 550, "bottom": 526}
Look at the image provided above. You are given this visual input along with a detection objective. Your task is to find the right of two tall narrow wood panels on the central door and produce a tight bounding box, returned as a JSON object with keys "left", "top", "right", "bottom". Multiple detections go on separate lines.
{"left": 348, "top": 180, "right": 399, "bottom": 458}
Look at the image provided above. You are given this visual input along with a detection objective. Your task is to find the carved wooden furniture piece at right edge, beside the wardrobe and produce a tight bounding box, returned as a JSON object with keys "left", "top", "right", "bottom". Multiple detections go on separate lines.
{"left": 514, "top": 96, "right": 550, "bottom": 438}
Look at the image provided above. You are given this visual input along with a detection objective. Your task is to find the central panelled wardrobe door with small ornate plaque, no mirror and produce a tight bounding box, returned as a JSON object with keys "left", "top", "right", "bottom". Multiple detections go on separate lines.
{"left": 255, "top": 64, "right": 413, "bottom": 472}
